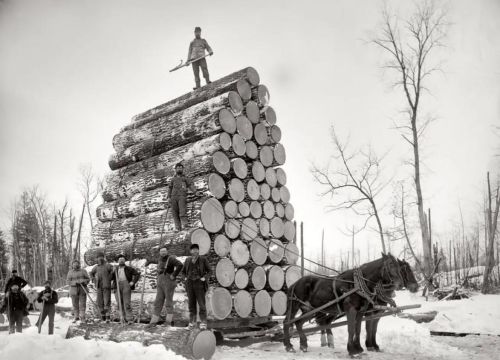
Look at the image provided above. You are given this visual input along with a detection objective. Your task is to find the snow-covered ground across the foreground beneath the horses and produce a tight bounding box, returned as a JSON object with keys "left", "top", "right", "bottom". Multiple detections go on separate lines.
{"left": 0, "top": 292, "right": 500, "bottom": 360}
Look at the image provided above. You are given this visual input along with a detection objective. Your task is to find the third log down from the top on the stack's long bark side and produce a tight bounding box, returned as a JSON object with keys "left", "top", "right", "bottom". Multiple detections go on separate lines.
{"left": 108, "top": 105, "right": 239, "bottom": 170}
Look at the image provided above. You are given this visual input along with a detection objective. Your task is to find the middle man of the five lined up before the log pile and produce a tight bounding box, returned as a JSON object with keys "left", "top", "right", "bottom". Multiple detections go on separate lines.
{"left": 111, "top": 254, "right": 141, "bottom": 324}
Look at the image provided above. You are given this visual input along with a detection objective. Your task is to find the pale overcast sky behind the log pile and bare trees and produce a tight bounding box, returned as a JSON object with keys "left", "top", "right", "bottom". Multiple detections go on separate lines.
{"left": 0, "top": 0, "right": 500, "bottom": 268}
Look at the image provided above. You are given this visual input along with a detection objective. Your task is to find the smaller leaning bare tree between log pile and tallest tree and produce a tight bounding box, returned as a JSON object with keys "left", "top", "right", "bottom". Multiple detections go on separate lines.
{"left": 311, "top": 128, "right": 390, "bottom": 253}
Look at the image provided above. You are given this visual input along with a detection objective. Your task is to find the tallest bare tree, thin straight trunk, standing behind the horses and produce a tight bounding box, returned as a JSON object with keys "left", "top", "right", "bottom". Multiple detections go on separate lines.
{"left": 372, "top": 1, "right": 448, "bottom": 274}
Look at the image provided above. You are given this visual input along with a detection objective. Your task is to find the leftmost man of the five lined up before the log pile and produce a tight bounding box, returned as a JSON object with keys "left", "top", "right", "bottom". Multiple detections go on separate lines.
{"left": 66, "top": 260, "right": 90, "bottom": 322}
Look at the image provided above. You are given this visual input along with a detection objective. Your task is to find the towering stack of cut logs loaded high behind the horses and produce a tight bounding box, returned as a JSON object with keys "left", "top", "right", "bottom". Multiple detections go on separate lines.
{"left": 85, "top": 68, "right": 300, "bottom": 320}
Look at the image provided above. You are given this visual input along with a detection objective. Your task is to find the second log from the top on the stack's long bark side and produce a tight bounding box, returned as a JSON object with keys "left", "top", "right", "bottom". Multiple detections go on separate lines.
{"left": 113, "top": 91, "right": 242, "bottom": 152}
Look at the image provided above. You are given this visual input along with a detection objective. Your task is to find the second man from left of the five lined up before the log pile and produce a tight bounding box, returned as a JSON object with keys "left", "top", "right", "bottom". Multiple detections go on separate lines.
{"left": 90, "top": 252, "right": 113, "bottom": 322}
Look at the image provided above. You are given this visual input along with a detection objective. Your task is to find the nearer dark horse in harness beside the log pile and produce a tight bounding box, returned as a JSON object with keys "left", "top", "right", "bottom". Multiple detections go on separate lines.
{"left": 283, "top": 254, "right": 403, "bottom": 355}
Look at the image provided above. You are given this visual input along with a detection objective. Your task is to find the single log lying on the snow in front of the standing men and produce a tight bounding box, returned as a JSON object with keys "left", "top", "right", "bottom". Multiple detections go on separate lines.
{"left": 66, "top": 323, "right": 216, "bottom": 360}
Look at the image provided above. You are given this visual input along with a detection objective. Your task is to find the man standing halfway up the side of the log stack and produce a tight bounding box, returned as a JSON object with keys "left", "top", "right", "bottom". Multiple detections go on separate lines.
{"left": 168, "top": 163, "right": 203, "bottom": 231}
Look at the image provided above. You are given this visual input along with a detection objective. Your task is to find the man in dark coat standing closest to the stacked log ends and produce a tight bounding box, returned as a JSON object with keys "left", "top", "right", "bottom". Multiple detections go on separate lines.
{"left": 182, "top": 244, "right": 210, "bottom": 329}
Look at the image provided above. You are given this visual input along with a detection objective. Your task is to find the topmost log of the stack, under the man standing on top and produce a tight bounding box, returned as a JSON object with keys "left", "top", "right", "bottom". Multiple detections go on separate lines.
{"left": 124, "top": 67, "right": 260, "bottom": 130}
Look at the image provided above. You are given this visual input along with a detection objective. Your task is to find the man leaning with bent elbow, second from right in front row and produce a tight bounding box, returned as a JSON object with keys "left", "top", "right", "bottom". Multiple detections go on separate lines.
{"left": 148, "top": 246, "right": 182, "bottom": 327}
